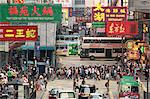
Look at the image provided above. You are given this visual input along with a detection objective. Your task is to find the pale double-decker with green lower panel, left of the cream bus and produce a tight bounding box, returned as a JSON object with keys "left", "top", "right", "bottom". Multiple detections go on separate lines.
{"left": 56, "top": 35, "right": 80, "bottom": 56}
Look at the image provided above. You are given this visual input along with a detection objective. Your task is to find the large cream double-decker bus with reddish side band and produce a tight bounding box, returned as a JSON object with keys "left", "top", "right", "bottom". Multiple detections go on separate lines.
{"left": 80, "top": 37, "right": 125, "bottom": 60}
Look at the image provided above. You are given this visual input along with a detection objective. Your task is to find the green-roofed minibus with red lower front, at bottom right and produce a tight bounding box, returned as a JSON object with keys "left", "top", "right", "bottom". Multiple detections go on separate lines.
{"left": 118, "top": 76, "right": 140, "bottom": 99}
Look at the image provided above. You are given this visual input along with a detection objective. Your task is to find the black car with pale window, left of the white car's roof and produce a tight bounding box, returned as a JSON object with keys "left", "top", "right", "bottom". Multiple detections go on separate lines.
{"left": 78, "top": 84, "right": 96, "bottom": 99}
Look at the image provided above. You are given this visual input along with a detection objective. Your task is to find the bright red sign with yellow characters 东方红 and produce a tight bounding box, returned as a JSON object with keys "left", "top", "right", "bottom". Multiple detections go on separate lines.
{"left": 106, "top": 22, "right": 138, "bottom": 36}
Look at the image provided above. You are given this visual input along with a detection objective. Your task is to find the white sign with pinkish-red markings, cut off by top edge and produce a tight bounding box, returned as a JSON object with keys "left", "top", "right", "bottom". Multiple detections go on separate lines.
{"left": 53, "top": 0, "right": 73, "bottom": 7}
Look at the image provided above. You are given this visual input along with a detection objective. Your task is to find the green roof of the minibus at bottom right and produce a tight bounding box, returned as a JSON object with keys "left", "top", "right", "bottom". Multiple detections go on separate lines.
{"left": 119, "top": 76, "right": 139, "bottom": 86}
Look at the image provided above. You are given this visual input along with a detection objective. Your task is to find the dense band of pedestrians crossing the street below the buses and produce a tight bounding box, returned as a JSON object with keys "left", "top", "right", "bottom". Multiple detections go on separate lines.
{"left": 49, "top": 62, "right": 141, "bottom": 80}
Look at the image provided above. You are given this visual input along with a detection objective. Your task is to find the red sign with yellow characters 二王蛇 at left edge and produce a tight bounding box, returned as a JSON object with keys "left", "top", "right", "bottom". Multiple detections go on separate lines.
{"left": 0, "top": 26, "right": 38, "bottom": 41}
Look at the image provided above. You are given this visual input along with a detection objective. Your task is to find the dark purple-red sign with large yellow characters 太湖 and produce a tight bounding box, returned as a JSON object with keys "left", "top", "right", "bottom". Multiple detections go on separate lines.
{"left": 92, "top": 3, "right": 127, "bottom": 22}
